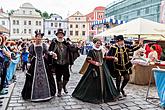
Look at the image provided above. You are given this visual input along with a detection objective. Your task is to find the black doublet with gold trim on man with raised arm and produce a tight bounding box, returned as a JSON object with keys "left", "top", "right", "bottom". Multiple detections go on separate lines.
{"left": 107, "top": 45, "right": 140, "bottom": 73}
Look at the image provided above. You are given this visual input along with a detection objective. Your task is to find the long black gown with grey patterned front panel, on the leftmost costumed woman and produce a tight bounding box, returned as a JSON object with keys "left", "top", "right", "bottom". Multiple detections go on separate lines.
{"left": 22, "top": 44, "right": 56, "bottom": 101}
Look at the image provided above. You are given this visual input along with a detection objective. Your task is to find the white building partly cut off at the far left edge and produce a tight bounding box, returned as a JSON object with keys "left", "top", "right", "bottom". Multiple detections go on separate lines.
{"left": 0, "top": 8, "right": 9, "bottom": 29}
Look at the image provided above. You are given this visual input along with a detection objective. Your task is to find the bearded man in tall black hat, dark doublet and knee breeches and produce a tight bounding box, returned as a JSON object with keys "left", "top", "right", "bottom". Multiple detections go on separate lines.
{"left": 49, "top": 29, "right": 73, "bottom": 97}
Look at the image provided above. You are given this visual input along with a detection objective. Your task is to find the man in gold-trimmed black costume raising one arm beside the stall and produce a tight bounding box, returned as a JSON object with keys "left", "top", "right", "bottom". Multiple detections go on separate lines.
{"left": 107, "top": 35, "right": 143, "bottom": 97}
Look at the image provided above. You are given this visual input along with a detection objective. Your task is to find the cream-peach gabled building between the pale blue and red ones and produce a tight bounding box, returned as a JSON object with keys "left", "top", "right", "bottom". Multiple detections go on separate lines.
{"left": 67, "top": 11, "right": 88, "bottom": 42}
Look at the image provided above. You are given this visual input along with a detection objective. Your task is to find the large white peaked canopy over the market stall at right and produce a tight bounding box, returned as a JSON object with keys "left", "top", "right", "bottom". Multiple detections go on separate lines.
{"left": 96, "top": 18, "right": 165, "bottom": 37}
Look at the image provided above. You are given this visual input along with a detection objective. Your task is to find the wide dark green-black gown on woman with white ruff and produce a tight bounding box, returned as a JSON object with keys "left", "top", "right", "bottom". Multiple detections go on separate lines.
{"left": 72, "top": 49, "right": 119, "bottom": 103}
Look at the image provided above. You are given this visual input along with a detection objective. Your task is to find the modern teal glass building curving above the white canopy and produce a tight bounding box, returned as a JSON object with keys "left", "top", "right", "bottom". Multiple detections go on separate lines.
{"left": 105, "top": 0, "right": 162, "bottom": 22}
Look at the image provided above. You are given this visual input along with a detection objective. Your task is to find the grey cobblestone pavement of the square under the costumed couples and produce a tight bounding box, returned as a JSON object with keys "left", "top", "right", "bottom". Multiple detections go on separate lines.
{"left": 7, "top": 56, "right": 162, "bottom": 110}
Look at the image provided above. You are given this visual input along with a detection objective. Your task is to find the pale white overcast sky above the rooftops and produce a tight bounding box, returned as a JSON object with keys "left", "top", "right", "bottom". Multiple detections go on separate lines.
{"left": 0, "top": 0, "right": 114, "bottom": 18}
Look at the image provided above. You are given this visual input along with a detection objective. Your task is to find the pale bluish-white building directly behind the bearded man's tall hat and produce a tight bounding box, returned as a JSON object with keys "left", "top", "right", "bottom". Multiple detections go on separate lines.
{"left": 44, "top": 14, "right": 68, "bottom": 39}
